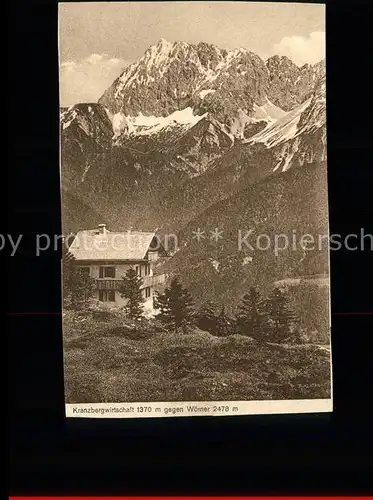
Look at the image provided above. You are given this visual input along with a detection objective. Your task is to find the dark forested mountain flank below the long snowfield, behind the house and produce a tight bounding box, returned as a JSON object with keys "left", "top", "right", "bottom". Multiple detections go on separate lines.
{"left": 61, "top": 105, "right": 237, "bottom": 230}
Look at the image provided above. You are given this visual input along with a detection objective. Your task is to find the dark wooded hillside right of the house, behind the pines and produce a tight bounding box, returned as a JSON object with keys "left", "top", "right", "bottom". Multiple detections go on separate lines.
{"left": 163, "top": 160, "right": 329, "bottom": 334}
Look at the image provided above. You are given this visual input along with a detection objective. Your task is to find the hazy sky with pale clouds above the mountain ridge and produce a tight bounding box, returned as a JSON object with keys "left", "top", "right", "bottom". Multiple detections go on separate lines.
{"left": 59, "top": 1, "right": 325, "bottom": 106}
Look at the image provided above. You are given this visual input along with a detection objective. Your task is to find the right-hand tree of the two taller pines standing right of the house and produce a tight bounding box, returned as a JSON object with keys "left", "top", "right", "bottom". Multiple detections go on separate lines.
{"left": 266, "top": 288, "right": 296, "bottom": 342}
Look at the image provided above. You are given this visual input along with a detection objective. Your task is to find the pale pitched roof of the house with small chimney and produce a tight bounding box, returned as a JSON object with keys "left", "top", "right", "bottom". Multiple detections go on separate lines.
{"left": 69, "top": 229, "right": 155, "bottom": 260}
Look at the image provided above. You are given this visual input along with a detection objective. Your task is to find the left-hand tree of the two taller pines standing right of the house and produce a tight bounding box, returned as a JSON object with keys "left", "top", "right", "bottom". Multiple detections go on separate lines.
{"left": 236, "top": 287, "right": 266, "bottom": 340}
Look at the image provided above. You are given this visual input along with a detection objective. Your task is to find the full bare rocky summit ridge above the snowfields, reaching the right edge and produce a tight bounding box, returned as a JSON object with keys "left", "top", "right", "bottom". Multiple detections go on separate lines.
{"left": 98, "top": 39, "right": 322, "bottom": 131}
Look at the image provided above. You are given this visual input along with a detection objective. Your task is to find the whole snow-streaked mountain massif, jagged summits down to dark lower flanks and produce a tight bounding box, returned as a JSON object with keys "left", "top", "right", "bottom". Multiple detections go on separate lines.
{"left": 61, "top": 37, "right": 325, "bottom": 234}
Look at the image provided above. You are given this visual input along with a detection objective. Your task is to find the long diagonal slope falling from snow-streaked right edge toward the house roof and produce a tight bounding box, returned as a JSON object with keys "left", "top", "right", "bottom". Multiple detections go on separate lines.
{"left": 150, "top": 75, "right": 326, "bottom": 230}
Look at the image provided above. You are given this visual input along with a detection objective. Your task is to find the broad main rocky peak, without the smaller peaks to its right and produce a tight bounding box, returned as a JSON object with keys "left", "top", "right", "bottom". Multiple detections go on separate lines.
{"left": 99, "top": 39, "right": 269, "bottom": 116}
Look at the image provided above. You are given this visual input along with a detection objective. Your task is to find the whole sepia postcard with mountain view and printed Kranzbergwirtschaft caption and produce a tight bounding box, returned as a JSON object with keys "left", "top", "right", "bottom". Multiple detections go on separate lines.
{"left": 59, "top": 2, "right": 332, "bottom": 418}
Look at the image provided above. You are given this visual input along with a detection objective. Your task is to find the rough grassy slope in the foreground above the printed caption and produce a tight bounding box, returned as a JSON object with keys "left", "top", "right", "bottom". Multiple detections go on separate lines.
{"left": 63, "top": 311, "right": 330, "bottom": 403}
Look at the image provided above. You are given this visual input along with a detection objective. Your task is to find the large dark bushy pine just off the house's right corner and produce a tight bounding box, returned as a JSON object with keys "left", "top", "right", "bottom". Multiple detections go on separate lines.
{"left": 155, "top": 278, "right": 193, "bottom": 333}
